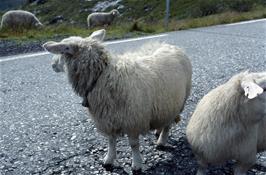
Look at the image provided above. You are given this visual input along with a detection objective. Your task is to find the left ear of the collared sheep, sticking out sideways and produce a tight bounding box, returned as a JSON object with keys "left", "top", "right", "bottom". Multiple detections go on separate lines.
{"left": 43, "top": 41, "right": 76, "bottom": 55}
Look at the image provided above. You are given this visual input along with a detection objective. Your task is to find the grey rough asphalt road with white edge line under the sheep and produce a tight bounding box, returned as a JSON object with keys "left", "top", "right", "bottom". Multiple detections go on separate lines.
{"left": 0, "top": 20, "right": 266, "bottom": 175}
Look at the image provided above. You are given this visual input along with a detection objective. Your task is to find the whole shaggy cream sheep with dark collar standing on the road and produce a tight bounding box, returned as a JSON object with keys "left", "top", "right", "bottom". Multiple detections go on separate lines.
{"left": 43, "top": 30, "right": 192, "bottom": 170}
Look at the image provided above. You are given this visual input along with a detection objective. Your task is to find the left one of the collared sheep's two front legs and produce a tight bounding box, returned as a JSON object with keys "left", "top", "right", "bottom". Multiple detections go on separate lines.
{"left": 103, "top": 136, "right": 116, "bottom": 166}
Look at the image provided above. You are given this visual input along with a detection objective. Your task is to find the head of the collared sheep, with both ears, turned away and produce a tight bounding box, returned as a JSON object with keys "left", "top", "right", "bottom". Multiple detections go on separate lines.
{"left": 43, "top": 29, "right": 105, "bottom": 72}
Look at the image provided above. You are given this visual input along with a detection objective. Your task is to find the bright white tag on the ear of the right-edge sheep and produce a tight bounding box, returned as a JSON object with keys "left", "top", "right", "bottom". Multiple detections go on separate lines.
{"left": 241, "top": 81, "right": 263, "bottom": 99}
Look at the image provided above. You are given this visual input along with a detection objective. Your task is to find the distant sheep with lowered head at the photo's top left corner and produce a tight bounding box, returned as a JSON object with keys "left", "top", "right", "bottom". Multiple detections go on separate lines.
{"left": 1, "top": 10, "right": 43, "bottom": 30}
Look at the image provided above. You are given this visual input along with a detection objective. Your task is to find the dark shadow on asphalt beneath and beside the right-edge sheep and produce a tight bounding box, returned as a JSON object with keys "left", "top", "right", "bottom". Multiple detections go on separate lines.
{"left": 144, "top": 136, "right": 266, "bottom": 175}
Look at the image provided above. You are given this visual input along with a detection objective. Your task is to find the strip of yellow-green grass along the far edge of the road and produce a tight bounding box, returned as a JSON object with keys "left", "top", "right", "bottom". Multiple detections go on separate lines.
{"left": 0, "top": 4, "right": 266, "bottom": 42}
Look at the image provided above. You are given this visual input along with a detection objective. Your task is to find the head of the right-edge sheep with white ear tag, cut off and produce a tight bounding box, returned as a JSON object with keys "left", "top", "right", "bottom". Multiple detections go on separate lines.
{"left": 241, "top": 72, "right": 266, "bottom": 118}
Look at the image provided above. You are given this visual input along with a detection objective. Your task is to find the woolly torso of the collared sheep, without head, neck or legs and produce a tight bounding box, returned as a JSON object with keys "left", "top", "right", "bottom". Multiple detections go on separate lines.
{"left": 91, "top": 43, "right": 191, "bottom": 134}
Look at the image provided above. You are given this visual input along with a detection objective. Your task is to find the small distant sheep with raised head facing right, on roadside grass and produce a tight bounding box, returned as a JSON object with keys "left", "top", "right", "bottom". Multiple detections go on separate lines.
{"left": 87, "top": 9, "right": 119, "bottom": 28}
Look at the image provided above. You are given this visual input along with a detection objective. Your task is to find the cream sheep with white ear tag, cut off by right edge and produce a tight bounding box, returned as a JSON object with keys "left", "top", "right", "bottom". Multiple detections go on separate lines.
{"left": 186, "top": 72, "right": 266, "bottom": 175}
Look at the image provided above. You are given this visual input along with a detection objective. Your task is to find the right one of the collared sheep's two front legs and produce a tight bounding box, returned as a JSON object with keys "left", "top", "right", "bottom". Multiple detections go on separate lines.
{"left": 128, "top": 136, "right": 142, "bottom": 170}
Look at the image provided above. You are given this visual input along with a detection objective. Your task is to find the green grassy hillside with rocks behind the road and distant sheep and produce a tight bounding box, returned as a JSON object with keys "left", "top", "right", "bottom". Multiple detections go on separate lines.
{"left": 0, "top": 0, "right": 266, "bottom": 39}
